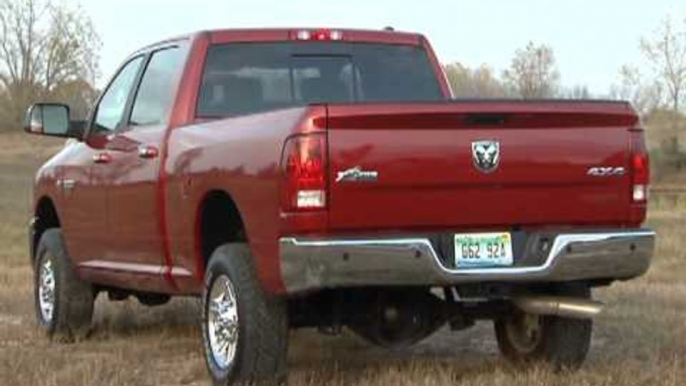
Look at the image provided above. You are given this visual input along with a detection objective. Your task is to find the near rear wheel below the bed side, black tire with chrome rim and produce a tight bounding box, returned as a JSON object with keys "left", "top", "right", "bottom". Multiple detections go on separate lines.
{"left": 202, "top": 243, "right": 288, "bottom": 385}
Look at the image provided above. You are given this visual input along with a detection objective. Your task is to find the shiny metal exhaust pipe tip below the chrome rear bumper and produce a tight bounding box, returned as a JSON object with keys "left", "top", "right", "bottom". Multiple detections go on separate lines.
{"left": 512, "top": 296, "right": 603, "bottom": 319}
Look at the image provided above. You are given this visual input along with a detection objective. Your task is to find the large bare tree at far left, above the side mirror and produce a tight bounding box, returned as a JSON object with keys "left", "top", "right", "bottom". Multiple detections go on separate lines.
{"left": 0, "top": 0, "right": 100, "bottom": 130}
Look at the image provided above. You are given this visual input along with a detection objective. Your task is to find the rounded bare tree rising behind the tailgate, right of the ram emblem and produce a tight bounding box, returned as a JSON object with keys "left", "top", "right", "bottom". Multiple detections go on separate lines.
{"left": 503, "top": 42, "right": 560, "bottom": 99}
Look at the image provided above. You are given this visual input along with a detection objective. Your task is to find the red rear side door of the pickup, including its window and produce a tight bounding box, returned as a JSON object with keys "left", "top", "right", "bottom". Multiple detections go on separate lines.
{"left": 87, "top": 46, "right": 184, "bottom": 291}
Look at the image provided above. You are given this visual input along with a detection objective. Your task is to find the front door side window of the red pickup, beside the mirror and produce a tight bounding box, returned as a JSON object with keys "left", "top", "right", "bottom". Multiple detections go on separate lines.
{"left": 93, "top": 56, "right": 143, "bottom": 132}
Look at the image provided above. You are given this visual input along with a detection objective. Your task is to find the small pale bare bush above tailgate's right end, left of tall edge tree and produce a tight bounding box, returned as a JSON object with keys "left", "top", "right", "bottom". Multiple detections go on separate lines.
{"left": 610, "top": 65, "right": 664, "bottom": 116}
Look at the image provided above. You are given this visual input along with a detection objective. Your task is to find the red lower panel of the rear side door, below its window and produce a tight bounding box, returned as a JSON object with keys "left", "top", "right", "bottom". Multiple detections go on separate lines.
{"left": 76, "top": 125, "right": 171, "bottom": 292}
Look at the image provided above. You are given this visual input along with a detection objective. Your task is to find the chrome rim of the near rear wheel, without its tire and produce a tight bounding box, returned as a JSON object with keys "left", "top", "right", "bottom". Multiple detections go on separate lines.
{"left": 207, "top": 275, "right": 238, "bottom": 370}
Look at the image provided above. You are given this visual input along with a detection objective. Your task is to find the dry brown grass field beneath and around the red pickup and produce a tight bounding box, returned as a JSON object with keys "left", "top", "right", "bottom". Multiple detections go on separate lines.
{"left": 0, "top": 134, "right": 686, "bottom": 386}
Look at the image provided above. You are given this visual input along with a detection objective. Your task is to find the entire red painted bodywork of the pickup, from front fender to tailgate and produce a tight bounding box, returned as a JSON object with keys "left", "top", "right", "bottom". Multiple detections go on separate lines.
{"left": 29, "top": 29, "right": 645, "bottom": 294}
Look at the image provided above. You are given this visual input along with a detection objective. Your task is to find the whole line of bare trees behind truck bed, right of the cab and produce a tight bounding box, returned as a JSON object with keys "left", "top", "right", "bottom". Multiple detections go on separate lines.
{"left": 444, "top": 18, "right": 686, "bottom": 180}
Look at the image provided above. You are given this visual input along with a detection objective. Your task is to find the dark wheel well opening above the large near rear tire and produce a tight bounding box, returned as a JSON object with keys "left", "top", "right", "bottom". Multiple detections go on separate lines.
{"left": 198, "top": 191, "right": 247, "bottom": 274}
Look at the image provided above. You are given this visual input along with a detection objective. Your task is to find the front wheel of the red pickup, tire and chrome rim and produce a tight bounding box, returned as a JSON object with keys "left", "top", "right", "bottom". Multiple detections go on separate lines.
{"left": 34, "top": 228, "right": 94, "bottom": 341}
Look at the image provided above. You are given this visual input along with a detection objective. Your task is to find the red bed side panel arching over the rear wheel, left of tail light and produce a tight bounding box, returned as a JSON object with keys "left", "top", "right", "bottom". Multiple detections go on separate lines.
{"left": 166, "top": 107, "right": 324, "bottom": 289}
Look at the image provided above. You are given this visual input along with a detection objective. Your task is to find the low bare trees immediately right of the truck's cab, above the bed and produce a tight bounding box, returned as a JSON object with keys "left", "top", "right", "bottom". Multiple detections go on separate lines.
{"left": 445, "top": 63, "right": 505, "bottom": 98}
